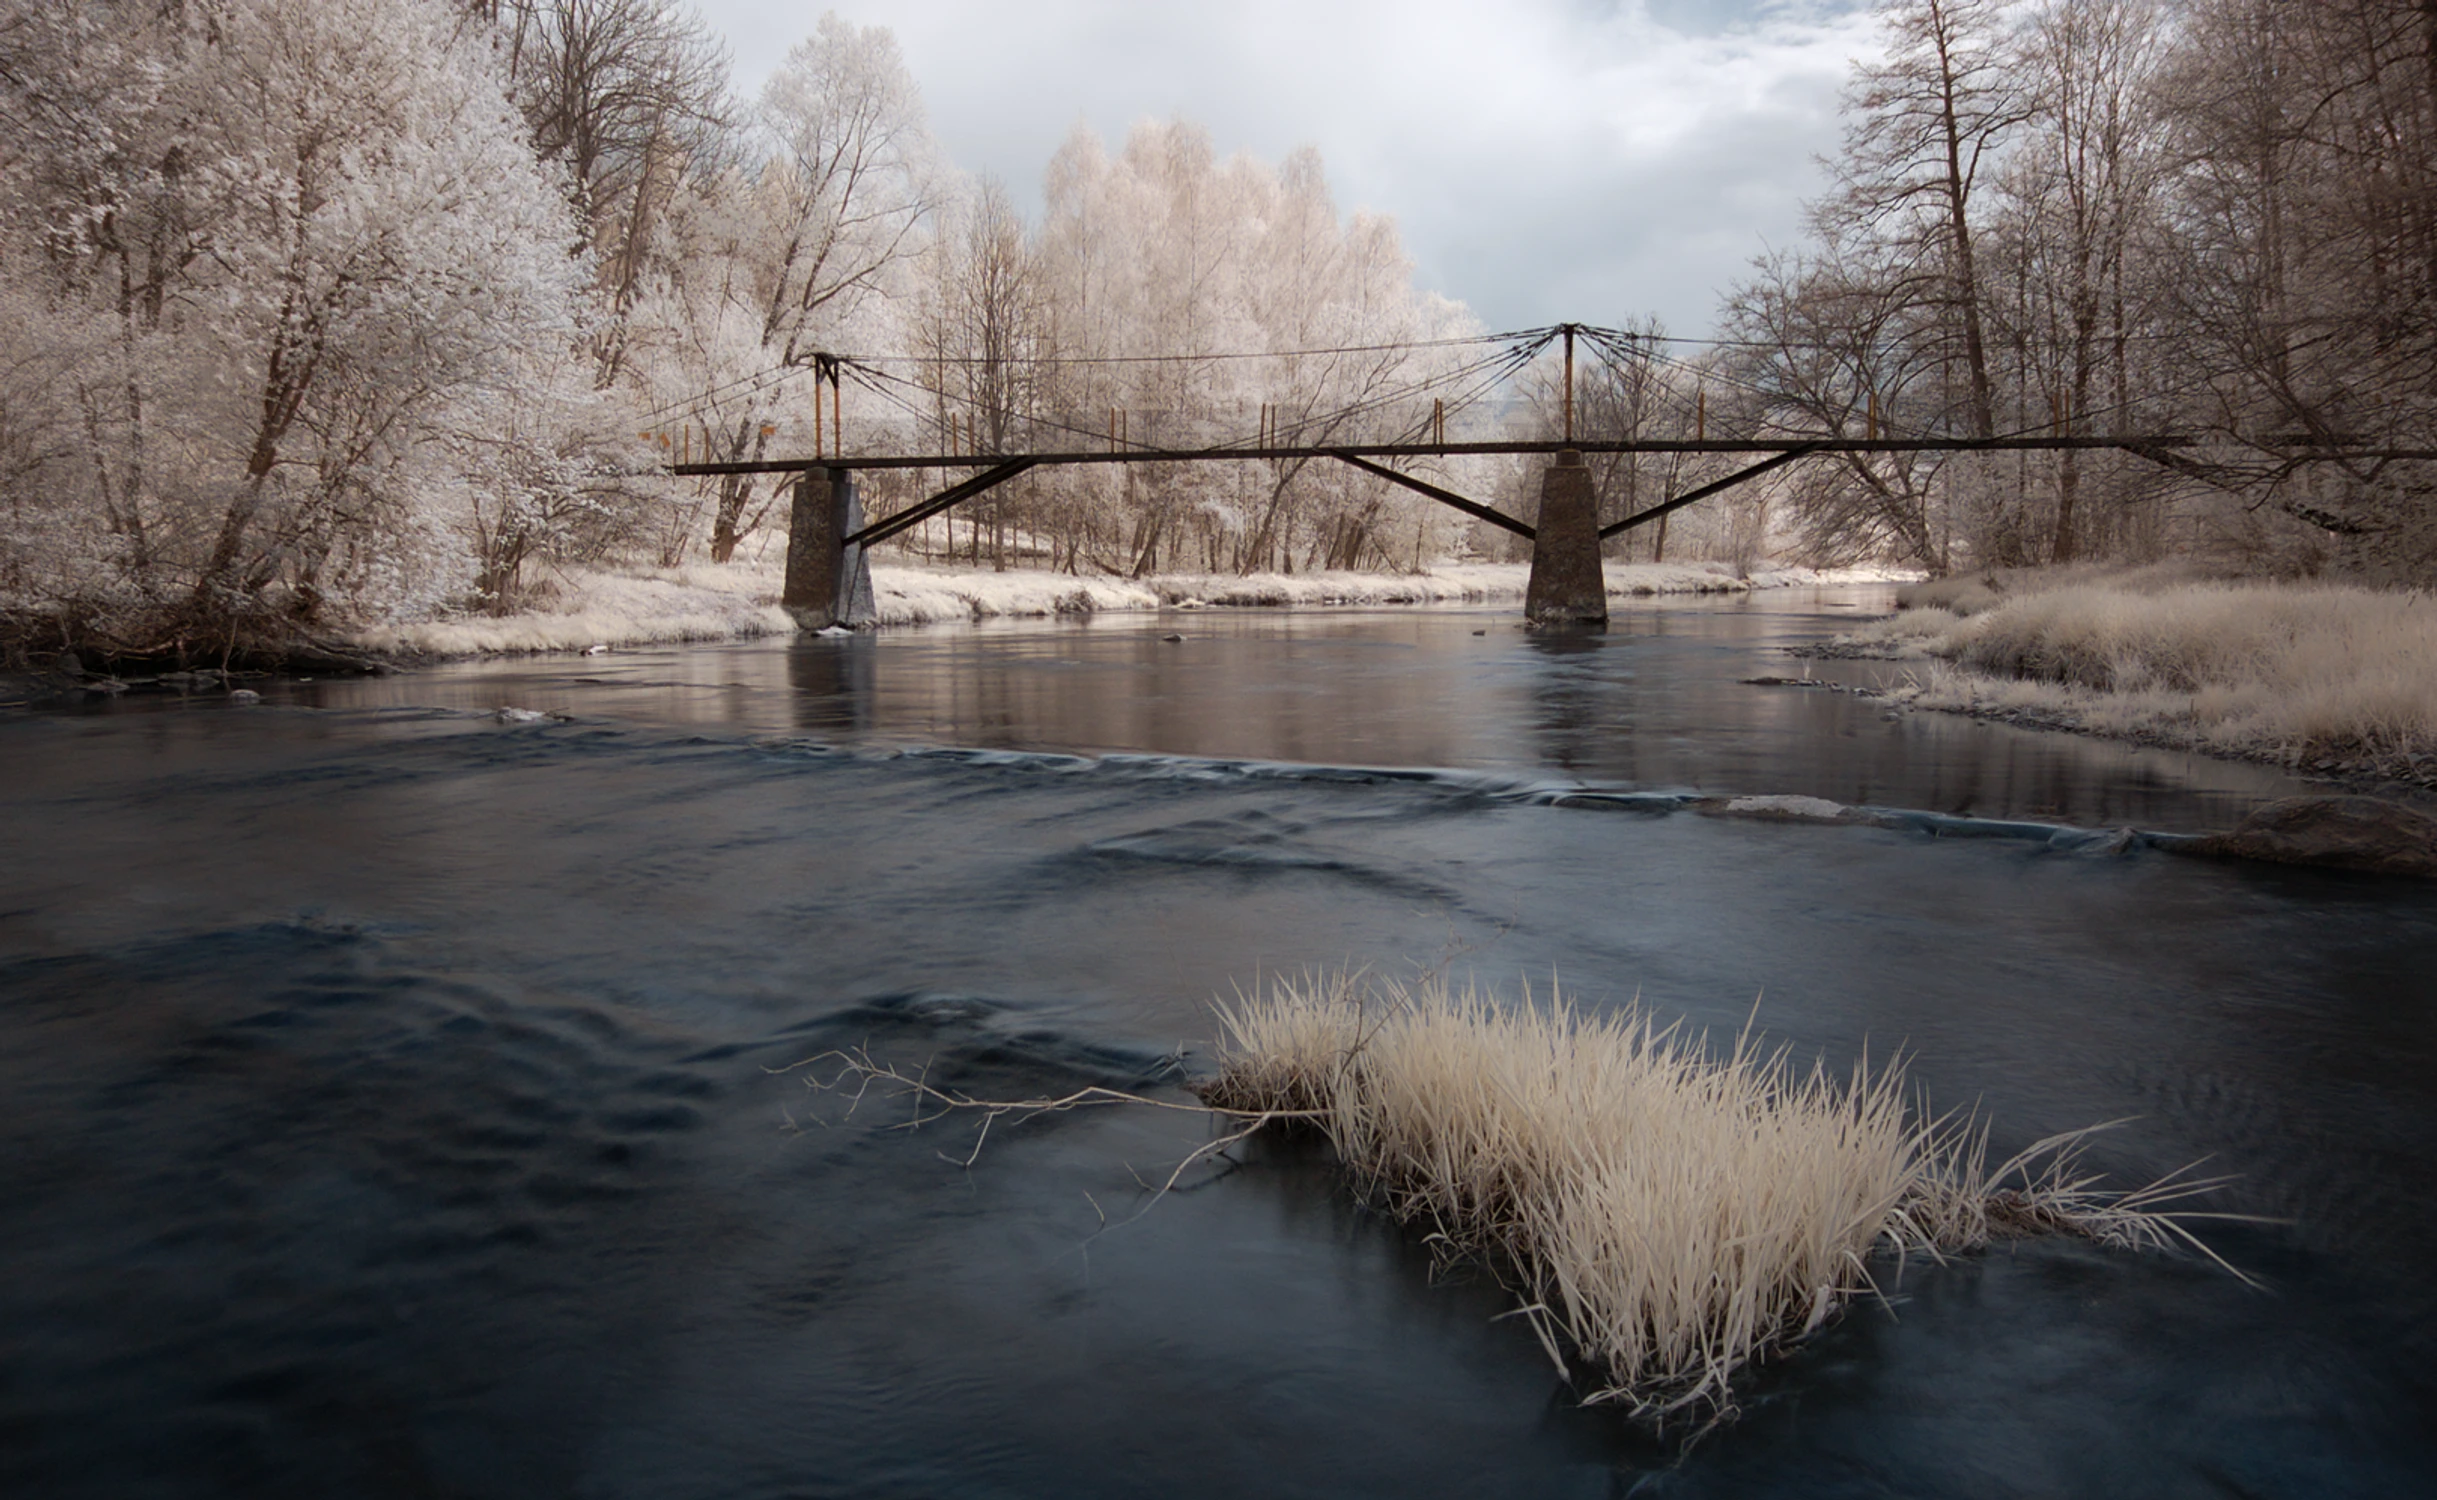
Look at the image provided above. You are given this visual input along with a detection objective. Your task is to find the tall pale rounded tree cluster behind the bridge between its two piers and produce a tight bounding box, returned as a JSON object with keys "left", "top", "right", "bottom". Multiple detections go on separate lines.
{"left": 1041, "top": 122, "right": 1472, "bottom": 572}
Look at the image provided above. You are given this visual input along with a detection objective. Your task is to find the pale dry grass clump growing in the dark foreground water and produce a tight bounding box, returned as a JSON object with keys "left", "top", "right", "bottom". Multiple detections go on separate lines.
{"left": 1199, "top": 974, "right": 2223, "bottom": 1415}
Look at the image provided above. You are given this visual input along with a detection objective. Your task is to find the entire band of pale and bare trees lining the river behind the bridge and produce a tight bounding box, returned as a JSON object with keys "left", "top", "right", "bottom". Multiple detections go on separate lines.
{"left": 0, "top": 0, "right": 2437, "bottom": 653}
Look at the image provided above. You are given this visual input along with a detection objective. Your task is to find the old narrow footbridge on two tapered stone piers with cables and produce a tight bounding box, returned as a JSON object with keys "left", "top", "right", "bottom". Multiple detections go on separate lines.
{"left": 668, "top": 324, "right": 2368, "bottom": 631}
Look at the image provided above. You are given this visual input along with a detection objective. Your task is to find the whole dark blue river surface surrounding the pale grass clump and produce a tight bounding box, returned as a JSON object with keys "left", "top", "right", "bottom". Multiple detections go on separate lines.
{"left": 0, "top": 597, "right": 2437, "bottom": 1498}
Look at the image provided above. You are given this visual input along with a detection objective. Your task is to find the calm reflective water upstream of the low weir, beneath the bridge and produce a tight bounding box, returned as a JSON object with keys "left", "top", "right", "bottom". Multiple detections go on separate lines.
{"left": 288, "top": 589, "right": 2301, "bottom": 830}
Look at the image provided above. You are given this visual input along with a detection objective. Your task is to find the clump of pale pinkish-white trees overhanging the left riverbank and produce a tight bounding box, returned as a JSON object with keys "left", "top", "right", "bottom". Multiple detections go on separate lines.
{"left": 7, "top": 0, "right": 587, "bottom": 650}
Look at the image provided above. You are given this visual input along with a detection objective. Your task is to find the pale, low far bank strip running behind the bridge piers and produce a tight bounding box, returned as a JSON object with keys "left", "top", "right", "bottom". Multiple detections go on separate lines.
{"left": 356, "top": 558, "right": 1915, "bottom": 655}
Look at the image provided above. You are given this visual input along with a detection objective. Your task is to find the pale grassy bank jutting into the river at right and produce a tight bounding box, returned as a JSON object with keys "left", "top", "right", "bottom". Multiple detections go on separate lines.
{"left": 1845, "top": 577, "right": 2437, "bottom": 782}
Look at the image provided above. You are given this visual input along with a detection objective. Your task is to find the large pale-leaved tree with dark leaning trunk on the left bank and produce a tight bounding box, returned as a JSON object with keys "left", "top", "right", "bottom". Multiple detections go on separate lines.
{"left": 190, "top": 0, "right": 580, "bottom": 604}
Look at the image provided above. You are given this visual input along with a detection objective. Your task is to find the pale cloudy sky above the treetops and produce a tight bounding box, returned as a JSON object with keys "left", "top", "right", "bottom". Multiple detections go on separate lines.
{"left": 699, "top": 0, "right": 1874, "bottom": 336}
